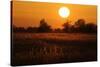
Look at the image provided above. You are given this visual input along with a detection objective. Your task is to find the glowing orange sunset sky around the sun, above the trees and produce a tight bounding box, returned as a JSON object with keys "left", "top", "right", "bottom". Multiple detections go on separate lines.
{"left": 12, "top": 1, "right": 97, "bottom": 28}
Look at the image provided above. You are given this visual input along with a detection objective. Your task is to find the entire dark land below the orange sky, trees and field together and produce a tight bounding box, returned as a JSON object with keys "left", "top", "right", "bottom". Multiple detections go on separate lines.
{"left": 11, "top": 19, "right": 97, "bottom": 66}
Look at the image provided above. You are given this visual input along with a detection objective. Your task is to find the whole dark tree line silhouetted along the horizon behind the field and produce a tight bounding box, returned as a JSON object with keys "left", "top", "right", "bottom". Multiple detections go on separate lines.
{"left": 12, "top": 19, "right": 97, "bottom": 33}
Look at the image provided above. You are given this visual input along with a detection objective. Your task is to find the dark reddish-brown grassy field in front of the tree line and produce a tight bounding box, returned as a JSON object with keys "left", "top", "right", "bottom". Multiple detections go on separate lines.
{"left": 11, "top": 33, "right": 97, "bottom": 65}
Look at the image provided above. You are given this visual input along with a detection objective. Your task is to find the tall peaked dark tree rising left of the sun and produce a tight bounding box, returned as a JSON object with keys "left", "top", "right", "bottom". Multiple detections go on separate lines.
{"left": 38, "top": 19, "right": 52, "bottom": 32}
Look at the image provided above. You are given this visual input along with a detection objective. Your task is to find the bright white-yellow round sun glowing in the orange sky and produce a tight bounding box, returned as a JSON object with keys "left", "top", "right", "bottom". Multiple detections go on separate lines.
{"left": 58, "top": 7, "right": 70, "bottom": 18}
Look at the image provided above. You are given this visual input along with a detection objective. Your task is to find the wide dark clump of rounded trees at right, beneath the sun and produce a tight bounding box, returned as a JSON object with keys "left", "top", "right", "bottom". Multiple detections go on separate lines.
{"left": 62, "top": 19, "right": 97, "bottom": 33}
